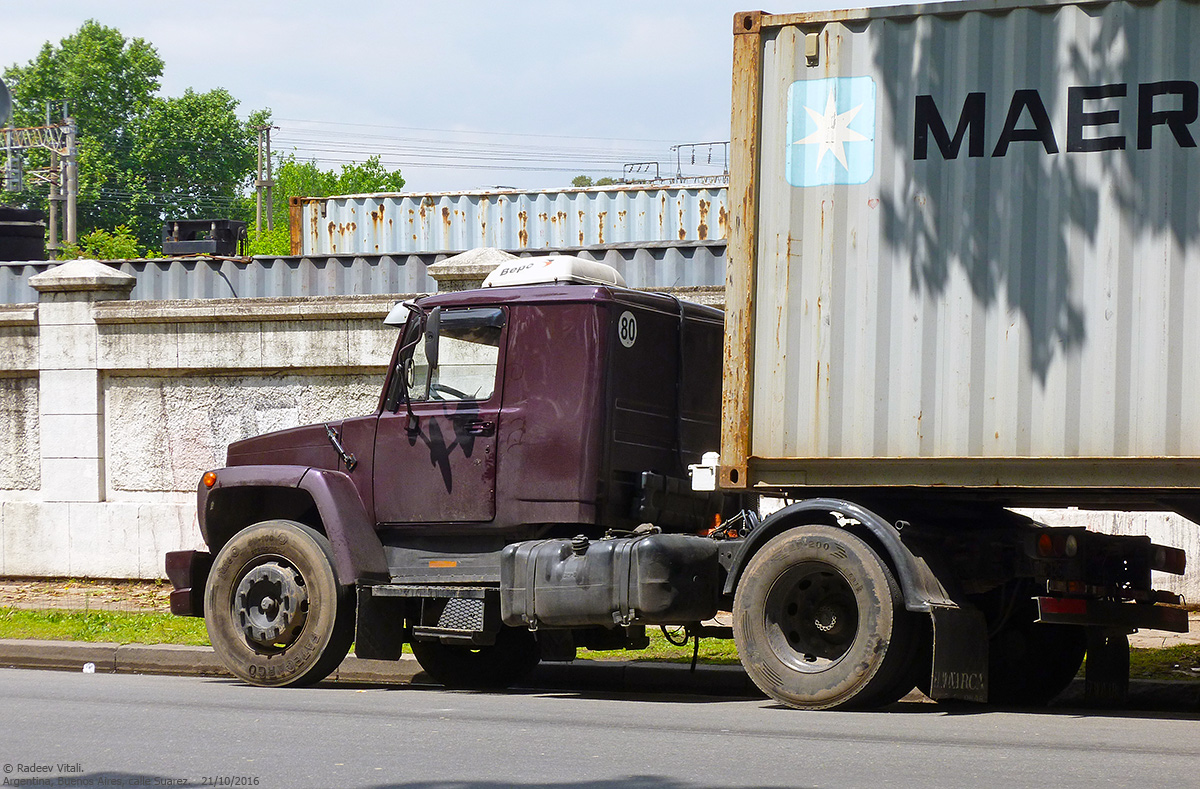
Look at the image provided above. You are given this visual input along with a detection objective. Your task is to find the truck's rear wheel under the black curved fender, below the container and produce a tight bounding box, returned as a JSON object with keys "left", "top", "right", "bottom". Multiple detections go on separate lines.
{"left": 733, "top": 525, "right": 919, "bottom": 710}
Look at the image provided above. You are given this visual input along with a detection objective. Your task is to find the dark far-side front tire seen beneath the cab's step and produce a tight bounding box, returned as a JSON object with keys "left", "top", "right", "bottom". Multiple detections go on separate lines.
{"left": 412, "top": 627, "right": 541, "bottom": 691}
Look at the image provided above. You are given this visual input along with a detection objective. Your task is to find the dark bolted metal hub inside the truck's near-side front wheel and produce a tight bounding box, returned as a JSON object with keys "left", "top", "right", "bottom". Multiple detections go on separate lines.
{"left": 234, "top": 562, "right": 308, "bottom": 650}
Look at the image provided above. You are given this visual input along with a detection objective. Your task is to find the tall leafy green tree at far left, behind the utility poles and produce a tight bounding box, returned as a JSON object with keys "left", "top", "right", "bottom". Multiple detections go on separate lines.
{"left": 5, "top": 20, "right": 269, "bottom": 247}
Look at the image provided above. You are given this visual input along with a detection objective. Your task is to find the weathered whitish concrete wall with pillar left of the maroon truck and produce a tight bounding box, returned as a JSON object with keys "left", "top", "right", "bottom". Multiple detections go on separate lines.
{"left": 0, "top": 261, "right": 403, "bottom": 578}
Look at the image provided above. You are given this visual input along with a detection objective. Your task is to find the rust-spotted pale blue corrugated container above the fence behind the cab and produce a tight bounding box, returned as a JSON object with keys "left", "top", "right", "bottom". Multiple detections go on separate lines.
{"left": 292, "top": 185, "right": 727, "bottom": 255}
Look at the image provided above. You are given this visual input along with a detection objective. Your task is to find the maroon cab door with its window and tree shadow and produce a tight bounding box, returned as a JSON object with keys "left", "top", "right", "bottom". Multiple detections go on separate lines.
{"left": 374, "top": 307, "right": 508, "bottom": 524}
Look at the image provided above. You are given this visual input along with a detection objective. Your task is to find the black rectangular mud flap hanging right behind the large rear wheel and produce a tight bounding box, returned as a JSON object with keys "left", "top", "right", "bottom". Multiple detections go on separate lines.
{"left": 929, "top": 606, "right": 988, "bottom": 701}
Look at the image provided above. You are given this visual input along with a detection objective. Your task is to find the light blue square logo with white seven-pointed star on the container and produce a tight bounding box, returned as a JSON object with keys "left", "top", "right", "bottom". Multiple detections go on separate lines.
{"left": 787, "top": 77, "right": 875, "bottom": 186}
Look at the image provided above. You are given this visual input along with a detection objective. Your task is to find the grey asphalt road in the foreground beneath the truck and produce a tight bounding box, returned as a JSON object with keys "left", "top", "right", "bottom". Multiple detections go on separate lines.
{"left": 0, "top": 669, "right": 1200, "bottom": 789}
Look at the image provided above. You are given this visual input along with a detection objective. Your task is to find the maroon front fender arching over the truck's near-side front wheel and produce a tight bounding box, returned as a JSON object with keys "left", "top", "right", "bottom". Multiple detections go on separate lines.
{"left": 197, "top": 465, "right": 389, "bottom": 583}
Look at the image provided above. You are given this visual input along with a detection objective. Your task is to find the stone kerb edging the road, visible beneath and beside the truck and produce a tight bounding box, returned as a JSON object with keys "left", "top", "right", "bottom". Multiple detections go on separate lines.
{"left": 0, "top": 639, "right": 1200, "bottom": 712}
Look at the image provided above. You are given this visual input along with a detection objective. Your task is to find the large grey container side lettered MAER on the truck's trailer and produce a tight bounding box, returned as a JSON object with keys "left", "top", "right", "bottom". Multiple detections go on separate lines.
{"left": 722, "top": 0, "right": 1200, "bottom": 488}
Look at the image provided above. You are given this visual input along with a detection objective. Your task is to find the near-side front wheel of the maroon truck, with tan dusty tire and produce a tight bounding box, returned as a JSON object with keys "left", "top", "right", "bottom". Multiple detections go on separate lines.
{"left": 204, "top": 520, "right": 354, "bottom": 687}
